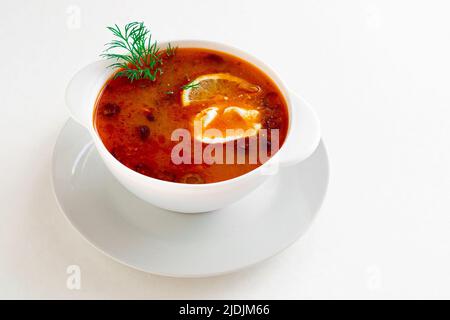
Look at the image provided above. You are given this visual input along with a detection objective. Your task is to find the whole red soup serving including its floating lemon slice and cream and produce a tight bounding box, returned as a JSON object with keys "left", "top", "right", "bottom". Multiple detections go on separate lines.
{"left": 94, "top": 48, "right": 289, "bottom": 183}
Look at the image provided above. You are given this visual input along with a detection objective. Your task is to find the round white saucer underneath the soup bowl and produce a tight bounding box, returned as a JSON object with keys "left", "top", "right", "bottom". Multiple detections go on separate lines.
{"left": 53, "top": 120, "right": 328, "bottom": 277}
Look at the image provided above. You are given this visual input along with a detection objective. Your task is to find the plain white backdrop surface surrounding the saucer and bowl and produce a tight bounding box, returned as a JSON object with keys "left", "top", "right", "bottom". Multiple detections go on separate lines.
{"left": 0, "top": 0, "right": 450, "bottom": 299}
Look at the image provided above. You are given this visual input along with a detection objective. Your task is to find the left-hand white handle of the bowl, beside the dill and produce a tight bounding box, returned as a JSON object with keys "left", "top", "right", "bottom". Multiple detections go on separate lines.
{"left": 65, "top": 60, "right": 112, "bottom": 128}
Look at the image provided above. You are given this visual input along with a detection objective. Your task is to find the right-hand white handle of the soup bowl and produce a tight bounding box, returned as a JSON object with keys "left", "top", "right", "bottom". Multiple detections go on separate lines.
{"left": 279, "top": 92, "right": 321, "bottom": 166}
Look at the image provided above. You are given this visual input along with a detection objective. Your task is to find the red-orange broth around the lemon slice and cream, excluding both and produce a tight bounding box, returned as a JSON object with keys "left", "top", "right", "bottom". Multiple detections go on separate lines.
{"left": 94, "top": 48, "right": 289, "bottom": 183}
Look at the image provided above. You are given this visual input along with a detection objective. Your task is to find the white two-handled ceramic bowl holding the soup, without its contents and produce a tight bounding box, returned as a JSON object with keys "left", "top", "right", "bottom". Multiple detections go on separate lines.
{"left": 66, "top": 41, "right": 320, "bottom": 213}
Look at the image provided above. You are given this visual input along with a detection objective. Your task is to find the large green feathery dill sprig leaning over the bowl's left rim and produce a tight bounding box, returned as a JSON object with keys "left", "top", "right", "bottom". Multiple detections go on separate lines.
{"left": 101, "top": 22, "right": 176, "bottom": 82}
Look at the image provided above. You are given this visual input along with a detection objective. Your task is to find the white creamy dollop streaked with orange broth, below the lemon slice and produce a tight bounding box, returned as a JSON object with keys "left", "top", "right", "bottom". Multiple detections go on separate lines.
{"left": 194, "top": 106, "right": 261, "bottom": 143}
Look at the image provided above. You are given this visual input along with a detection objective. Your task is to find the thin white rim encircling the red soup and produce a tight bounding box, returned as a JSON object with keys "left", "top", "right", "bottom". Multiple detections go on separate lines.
{"left": 89, "top": 39, "right": 293, "bottom": 190}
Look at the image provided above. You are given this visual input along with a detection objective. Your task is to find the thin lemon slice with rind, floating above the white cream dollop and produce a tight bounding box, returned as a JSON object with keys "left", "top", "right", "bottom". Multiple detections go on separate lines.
{"left": 181, "top": 73, "right": 260, "bottom": 106}
